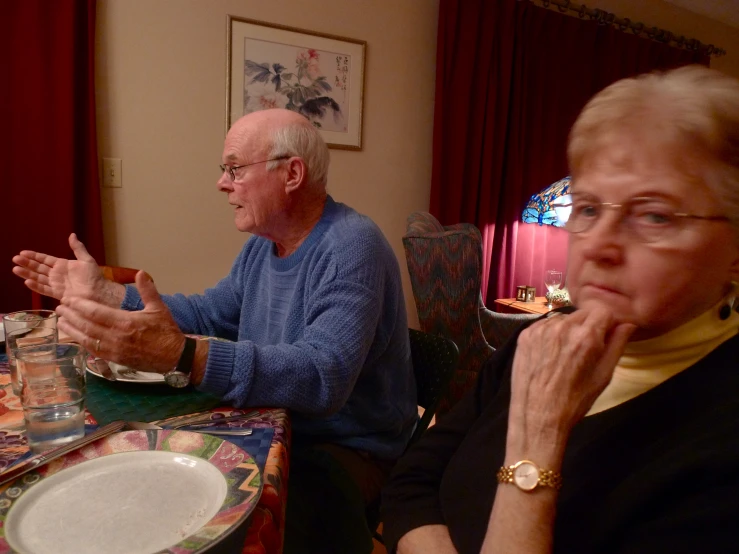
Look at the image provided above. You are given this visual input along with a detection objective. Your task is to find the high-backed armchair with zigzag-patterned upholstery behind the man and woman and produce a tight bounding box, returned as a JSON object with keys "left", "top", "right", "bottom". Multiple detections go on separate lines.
{"left": 403, "top": 212, "right": 537, "bottom": 414}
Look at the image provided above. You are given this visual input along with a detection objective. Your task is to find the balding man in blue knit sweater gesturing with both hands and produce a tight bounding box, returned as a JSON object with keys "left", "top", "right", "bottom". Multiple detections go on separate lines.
{"left": 13, "top": 110, "right": 416, "bottom": 552}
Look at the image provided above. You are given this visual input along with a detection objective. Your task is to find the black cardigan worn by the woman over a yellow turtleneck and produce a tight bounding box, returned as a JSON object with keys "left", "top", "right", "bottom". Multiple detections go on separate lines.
{"left": 383, "top": 326, "right": 739, "bottom": 554}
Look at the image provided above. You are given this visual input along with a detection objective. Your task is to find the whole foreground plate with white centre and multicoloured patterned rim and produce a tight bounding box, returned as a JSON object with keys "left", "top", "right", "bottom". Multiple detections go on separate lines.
{"left": 0, "top": 430, "right": 261, "bottom": 554}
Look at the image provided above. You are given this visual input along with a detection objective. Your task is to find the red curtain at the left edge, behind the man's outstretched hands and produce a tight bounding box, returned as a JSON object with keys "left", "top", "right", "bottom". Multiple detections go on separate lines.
{"left": 0, "top": 0, "right": 105, "bottom": 312}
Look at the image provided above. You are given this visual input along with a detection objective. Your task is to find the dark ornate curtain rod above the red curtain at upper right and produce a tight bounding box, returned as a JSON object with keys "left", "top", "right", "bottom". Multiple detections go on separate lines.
{"left": 530, "top": 0, "right": 726, "bottom": 57}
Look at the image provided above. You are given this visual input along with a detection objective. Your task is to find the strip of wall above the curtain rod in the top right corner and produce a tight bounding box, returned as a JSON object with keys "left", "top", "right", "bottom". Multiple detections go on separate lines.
{"left": 585, "top": 0, "right": 739, "bottom": 77}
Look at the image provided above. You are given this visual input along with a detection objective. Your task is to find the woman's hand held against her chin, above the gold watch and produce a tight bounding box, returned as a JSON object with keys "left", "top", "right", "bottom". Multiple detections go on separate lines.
{"left": 507, "top": 304, "right": 636, "bottom": 462}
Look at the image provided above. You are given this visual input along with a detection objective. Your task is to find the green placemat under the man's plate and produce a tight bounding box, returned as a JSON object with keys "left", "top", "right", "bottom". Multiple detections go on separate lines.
{"left": 86, "top": 372, "right": 223, "bottom": 425}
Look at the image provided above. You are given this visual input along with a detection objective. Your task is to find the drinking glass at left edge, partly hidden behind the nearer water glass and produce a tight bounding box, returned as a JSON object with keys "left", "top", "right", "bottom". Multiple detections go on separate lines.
{"left": 3, "top": 310, "right": 59, "bottom": 396}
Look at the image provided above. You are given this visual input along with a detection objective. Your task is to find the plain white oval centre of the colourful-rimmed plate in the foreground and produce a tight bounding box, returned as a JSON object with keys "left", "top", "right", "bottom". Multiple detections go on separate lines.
{"left": 6, "top": 452, "right": 226, "bottom": 554}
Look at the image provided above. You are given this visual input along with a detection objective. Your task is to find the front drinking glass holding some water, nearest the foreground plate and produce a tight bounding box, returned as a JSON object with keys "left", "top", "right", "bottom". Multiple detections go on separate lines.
{"left": 16, "top": 343, "right": 87, "bottom": 453}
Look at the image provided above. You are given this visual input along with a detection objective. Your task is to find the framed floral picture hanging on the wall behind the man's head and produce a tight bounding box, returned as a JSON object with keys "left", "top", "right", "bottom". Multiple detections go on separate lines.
{"left": 226, "top": 15, "right": 367, "bottom": 150}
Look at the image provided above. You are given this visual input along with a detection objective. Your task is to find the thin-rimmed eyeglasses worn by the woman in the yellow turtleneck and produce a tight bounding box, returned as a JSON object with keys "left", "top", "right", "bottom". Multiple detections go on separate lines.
{"left": 565, "top": 193, "right": 732, "bottom": 242}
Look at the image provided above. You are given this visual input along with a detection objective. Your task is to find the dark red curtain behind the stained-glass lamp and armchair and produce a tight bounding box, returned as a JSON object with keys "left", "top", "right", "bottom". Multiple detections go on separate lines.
{"left": 430, "top": 0, "right": 708, "bottom": 302}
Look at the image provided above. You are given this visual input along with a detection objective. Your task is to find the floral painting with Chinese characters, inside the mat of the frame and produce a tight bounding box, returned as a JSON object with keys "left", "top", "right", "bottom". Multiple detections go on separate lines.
{"left": 244, "top": 39, "right": 351, "bottom": 133}
